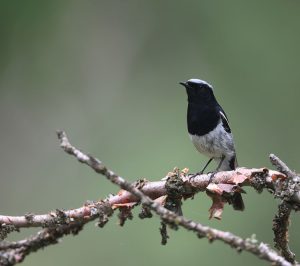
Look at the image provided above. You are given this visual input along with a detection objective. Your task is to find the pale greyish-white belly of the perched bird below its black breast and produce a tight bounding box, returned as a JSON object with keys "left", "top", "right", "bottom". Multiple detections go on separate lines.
{"left": 190, "top": 124, "right": 235, "bottom": 158}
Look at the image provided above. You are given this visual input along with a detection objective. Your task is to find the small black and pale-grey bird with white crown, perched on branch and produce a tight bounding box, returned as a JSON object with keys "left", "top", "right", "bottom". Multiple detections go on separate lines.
{"left": 180, "top": 79, "right": 237, "bottom": 173}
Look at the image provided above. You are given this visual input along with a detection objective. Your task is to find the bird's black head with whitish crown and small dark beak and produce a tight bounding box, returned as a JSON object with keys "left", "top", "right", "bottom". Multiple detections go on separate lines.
{"left": 179, "top": 79, "right": 215, "bottom": 103}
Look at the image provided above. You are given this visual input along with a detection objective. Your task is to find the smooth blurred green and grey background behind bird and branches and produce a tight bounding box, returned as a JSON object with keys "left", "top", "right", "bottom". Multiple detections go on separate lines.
{"left": 0, "top": 0, "right": 300, "bottom": 266}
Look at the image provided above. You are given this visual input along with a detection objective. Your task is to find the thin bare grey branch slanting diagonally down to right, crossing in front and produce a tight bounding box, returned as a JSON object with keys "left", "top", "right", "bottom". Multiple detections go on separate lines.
{"left": 54, "top": 131, "right": 296, "bottom": 265}
